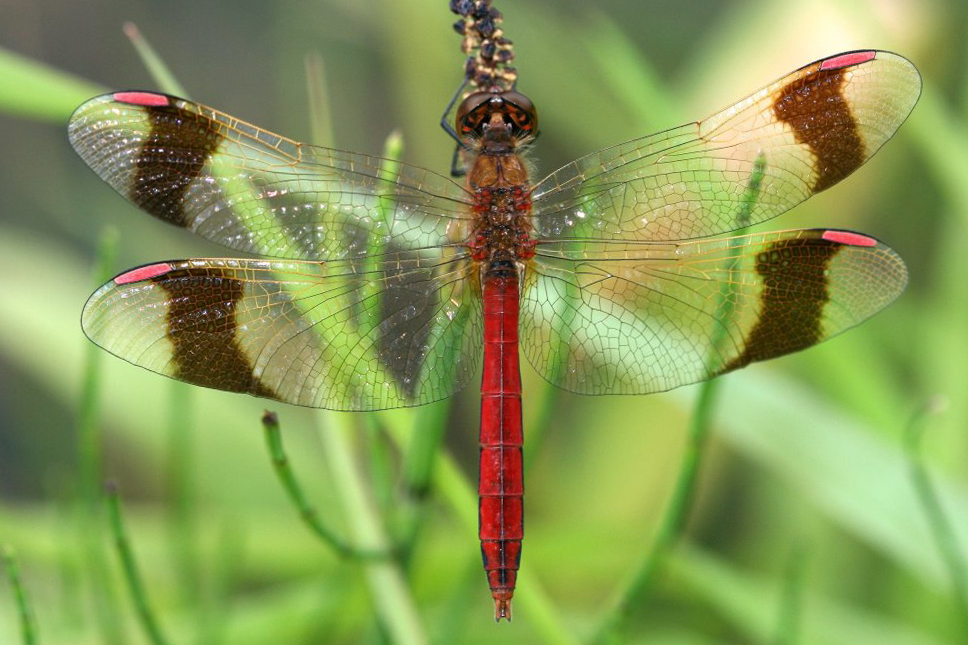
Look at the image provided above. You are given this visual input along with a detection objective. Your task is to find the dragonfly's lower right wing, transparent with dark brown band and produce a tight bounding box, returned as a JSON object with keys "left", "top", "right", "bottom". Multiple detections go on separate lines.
{"left": 521, "top": 230, "right": 907, "bottom": 394}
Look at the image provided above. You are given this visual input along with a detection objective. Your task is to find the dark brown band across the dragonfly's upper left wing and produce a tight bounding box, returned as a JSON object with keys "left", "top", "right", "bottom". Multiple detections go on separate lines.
{"left": 128, "top": 105, "right": 223, "bottom": 227}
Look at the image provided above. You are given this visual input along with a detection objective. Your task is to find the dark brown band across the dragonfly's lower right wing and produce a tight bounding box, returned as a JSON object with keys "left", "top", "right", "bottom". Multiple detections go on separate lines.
{"left": 720, "top": 239, "right": 842, "bottom": 373}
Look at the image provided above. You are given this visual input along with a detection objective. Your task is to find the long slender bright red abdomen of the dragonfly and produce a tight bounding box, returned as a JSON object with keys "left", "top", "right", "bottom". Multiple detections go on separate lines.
{"left": 478, "top": 263, "right": 524, "bottom": 620}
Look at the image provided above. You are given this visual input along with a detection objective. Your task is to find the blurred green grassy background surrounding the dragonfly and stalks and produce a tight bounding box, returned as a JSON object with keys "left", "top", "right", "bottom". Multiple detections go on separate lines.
{"left": 0, "top": 0, "right": 968, "bottom": 645}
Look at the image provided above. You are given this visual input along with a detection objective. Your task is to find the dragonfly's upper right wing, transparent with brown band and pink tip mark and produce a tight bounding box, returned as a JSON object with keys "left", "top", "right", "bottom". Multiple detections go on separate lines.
{"left": 532, "top": 51, "right": 921, "bottom": 241}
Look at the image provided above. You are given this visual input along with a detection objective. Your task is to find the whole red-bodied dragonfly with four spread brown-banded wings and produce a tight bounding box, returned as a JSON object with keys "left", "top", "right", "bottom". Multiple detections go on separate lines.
{"left": 69, "top": 50, "right": 921, "bottom": 620}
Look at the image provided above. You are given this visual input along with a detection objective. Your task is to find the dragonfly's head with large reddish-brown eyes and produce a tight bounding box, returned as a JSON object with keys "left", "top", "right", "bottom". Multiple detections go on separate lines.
{"left": 457, "top": 90, "right": 538, "bottom": 148}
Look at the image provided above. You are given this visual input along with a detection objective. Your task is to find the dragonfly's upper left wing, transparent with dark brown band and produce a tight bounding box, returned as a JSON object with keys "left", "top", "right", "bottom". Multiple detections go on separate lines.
{"left": 69, "top": 92, "right": 469, "bottom": 260}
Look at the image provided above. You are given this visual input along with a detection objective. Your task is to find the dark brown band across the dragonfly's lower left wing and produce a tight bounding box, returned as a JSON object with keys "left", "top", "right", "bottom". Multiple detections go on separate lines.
{"left": 152, "top": 267, "right": 279, "bottom": 399}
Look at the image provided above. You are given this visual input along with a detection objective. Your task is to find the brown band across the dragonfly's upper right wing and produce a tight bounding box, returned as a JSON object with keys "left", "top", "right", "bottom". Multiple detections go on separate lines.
{"left": 773, "top": 68, "right": 867, "bottom": 192}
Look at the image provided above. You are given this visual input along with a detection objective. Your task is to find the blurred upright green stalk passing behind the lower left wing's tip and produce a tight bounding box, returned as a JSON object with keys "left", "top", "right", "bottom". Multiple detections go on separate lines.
{"left": 77, "top": 226, "right": 126, "bottom": 645}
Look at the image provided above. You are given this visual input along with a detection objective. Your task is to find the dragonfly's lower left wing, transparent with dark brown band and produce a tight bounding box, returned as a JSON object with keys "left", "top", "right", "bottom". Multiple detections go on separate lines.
{"left": 82, "top": 251, "right": 482, "bottom": 410}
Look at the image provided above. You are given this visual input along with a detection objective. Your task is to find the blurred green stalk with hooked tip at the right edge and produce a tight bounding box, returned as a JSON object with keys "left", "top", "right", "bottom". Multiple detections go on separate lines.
{"left": 905, "top": 400, "right": 968, "bottom": 633}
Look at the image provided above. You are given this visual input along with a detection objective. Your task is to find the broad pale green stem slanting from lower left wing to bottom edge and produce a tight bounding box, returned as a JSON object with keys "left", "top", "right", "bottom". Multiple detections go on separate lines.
{"left": 319, "top": 412, "right": 427, "bottom": 645}
